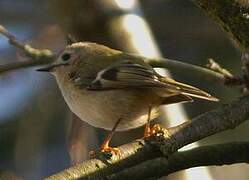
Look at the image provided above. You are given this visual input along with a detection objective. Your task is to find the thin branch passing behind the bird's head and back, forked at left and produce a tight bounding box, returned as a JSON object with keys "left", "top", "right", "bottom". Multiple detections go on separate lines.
{"left": 0, "top": 25, "right": 236, "bottom": 84}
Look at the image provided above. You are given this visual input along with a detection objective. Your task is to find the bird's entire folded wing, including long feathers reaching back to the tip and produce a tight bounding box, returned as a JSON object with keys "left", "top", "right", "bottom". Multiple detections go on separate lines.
{"left": 87, "top": 60, "right": 217, "bottom": 101}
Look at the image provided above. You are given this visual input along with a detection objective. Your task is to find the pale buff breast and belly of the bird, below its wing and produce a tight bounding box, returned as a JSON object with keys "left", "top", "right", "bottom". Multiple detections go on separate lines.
{"left": 54, "top": 74, "right": 160, "bottom": 131}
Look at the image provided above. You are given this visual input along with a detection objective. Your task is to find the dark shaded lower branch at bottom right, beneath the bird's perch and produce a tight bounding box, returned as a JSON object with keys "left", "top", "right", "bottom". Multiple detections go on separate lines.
{"left": 107, "top": 142, "right": 249, "bottom": 180}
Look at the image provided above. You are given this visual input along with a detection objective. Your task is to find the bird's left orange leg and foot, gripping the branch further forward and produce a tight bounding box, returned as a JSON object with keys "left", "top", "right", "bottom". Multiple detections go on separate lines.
{"left": 90, "top": 118, "right": 122, "bottom": 156}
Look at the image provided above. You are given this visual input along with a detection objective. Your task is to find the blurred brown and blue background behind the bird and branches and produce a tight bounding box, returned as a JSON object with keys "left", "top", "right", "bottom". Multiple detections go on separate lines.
{"left": 0, "top": 0, "right": 249, "bottom": 180}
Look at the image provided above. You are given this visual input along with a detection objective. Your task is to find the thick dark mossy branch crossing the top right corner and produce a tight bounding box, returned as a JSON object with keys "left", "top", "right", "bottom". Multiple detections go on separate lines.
{"left": 192, "top": 0, "right": 249, "bottom": 51}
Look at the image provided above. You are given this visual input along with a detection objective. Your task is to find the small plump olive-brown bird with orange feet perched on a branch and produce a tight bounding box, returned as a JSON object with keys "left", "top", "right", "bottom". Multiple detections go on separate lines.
{"left": 38, "top": 42, "right": 218, "bottom": 153}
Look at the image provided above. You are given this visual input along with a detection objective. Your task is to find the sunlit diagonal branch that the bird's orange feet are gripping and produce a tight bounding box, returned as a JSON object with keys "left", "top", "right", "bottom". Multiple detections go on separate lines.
{"left": 47, "top": 95, "right": 249, "bottom": 180}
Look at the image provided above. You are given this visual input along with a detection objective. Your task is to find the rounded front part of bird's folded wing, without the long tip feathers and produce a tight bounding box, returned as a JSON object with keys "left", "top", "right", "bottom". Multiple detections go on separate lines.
{"left": 88, "top": 60, "right": 165, "bottom": 90}
